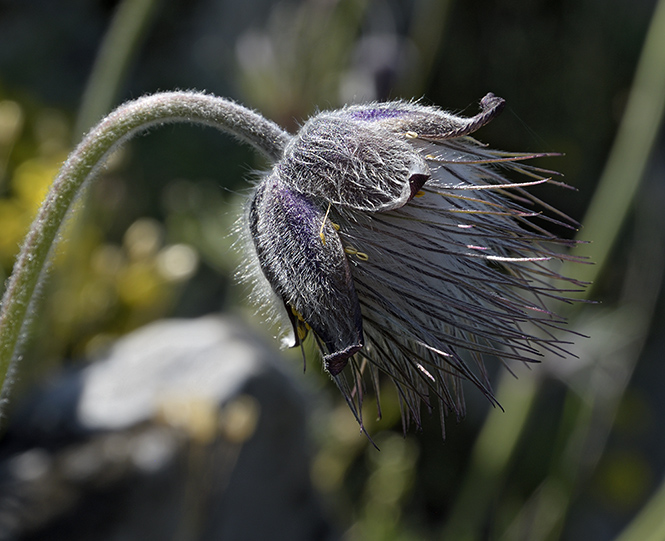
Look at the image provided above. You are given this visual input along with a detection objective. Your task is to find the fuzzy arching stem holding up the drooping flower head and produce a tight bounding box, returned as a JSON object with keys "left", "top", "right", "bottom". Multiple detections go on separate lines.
{"left": 0, "top": 92, "right": 290, "bottom": 404}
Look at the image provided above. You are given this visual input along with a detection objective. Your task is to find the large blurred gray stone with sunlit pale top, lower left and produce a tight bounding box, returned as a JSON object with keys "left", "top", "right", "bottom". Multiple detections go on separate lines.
{"left": 0, "top": 317, "right": 336, "bottom": 541}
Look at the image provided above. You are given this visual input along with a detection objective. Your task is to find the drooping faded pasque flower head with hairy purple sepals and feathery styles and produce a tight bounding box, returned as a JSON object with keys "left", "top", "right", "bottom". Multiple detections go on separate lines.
{"left": 244, "top": 94, "right": 572, "bottom": 434}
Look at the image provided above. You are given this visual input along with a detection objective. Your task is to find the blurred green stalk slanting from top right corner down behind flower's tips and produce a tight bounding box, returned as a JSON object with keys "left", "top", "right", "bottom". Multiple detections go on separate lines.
{"left": 443, "top": 0, "right": 665, "bottom": 539}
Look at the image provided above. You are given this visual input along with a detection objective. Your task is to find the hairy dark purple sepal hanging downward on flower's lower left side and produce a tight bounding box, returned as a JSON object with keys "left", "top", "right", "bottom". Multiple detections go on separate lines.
{"left": 249, "top": 175, "right": 364, "bottom": 375}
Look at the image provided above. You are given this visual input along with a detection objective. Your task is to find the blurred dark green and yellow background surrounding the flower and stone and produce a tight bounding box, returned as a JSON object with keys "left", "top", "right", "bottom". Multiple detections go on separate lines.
{"left": 0, "top": 0, "right": 665, "bottom": 541}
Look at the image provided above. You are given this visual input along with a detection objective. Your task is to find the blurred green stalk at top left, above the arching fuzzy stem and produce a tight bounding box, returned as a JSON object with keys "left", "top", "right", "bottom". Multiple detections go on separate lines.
{"left": 74, "top": 0, "right": 160, "bottom": 137}
